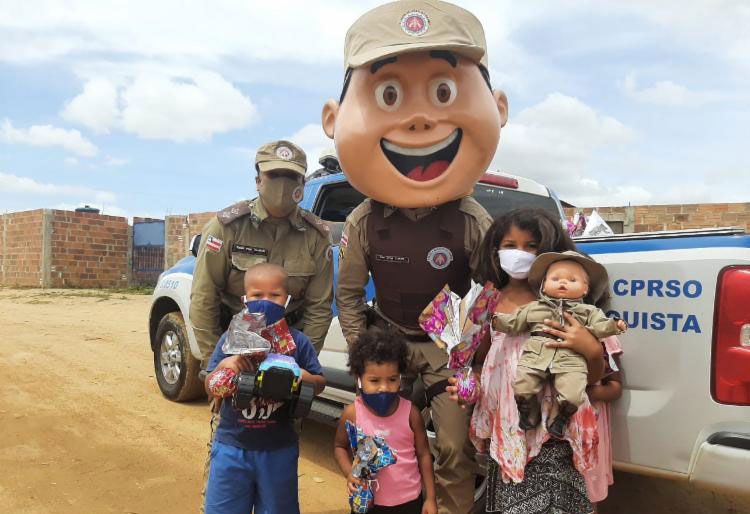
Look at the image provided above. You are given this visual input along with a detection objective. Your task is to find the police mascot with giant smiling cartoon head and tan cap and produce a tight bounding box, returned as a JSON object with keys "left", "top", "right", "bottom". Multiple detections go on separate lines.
{"left": 322, "top": 0, "right": 508, "bottom": 508}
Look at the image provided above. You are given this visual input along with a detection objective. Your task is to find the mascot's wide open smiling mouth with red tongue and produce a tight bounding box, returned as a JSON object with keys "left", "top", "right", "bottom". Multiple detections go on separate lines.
{"left": 380, "top": 129, "right": 462, "bottom": 182}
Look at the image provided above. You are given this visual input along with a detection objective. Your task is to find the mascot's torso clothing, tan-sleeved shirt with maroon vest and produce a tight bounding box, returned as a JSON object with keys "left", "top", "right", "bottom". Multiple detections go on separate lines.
{"left": 336, "top": 196, "right": 492, "bottom": 348}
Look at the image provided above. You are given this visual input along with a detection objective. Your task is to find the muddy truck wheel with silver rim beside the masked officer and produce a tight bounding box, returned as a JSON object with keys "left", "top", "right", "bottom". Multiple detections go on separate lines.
{"left": 154, "top": 312, "right": 205, "bottom": 402}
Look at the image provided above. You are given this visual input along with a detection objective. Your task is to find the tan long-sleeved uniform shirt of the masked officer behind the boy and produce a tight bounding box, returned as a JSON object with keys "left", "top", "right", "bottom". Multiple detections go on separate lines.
{"left": 190, "top": 198, "right": 333, "bottom": 359}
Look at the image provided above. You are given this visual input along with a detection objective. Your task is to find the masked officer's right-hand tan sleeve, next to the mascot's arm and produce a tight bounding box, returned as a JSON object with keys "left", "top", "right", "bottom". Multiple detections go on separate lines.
{"left": 302, "top": 231, "right": 333, "bottom": 353}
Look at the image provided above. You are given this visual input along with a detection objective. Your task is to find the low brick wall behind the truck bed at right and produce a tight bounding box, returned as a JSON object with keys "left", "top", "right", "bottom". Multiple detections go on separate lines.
{"left": 565, "top": 203, "right": 750, "bottom": 233}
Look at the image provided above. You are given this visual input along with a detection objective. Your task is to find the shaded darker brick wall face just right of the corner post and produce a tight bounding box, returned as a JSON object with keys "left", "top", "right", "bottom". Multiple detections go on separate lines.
{"left": 49, "top": 210, "right": 131, "bottom": 287}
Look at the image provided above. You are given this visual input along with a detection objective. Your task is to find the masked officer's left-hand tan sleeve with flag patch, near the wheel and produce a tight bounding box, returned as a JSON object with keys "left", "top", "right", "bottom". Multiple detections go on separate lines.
{"left": 190, "top": 218, "right": 232, "bottom": 361}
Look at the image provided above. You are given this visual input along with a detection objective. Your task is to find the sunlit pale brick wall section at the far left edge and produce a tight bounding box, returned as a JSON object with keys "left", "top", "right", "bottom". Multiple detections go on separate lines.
{"left": 0, "top": 209, "right": 44, "bottom": 287}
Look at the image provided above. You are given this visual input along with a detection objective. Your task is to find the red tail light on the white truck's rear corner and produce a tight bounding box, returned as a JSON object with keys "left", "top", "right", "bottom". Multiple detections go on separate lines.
{"left": 711, "top": 266, "right": 750, "bottom": 405}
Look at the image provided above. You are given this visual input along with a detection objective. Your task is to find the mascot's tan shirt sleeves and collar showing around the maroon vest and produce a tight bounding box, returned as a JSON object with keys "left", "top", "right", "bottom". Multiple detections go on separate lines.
{"left": 336, "top": 196, "right": 492, "bottom": 344}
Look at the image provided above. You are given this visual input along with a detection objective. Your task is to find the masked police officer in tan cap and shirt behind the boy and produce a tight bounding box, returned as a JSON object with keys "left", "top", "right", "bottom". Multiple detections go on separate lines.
{"left": 190, "top": 141, "right": 333, "bottom": 362}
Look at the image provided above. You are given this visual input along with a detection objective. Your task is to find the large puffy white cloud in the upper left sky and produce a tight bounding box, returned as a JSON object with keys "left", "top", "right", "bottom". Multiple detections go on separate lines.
{"left": 62, "top": 69, "right": 257, "bottom": 143}
